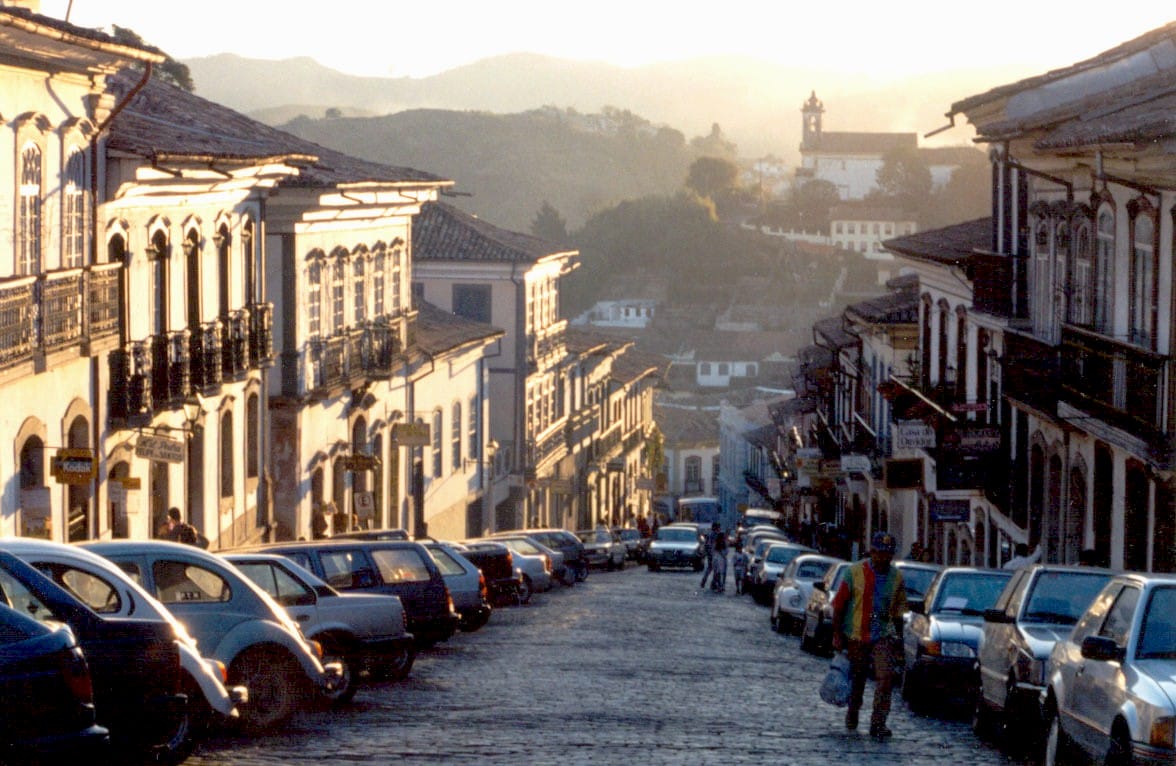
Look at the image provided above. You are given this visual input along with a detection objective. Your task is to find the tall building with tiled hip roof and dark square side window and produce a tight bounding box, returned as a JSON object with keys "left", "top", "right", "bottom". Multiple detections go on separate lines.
{"left": 412, "top": 202, "right": 577, "bottom": 529}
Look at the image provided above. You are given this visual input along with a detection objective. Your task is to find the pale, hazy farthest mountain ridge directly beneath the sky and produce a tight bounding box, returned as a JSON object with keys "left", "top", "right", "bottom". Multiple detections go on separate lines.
{"left": 183, "top": 49, "right": 1024, "bottom": 165}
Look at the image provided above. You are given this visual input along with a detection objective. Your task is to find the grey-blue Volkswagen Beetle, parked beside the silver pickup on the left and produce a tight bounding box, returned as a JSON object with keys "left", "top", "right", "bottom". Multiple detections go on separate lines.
{"left": 83, "top": 540, "right": 342, "bottom": 731}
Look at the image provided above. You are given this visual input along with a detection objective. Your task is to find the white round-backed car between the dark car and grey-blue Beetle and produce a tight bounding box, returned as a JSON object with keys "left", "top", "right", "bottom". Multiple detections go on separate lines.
{"left": 4, "top": 538, "right": 248, "bottom": 737}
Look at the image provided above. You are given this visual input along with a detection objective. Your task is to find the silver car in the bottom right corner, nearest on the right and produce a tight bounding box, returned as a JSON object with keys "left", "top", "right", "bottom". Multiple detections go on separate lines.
{"left": 1044, "top": 573, "right": 1176, "bottom": 766}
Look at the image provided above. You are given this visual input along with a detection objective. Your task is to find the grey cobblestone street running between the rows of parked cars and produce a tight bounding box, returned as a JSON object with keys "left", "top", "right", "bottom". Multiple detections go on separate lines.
{"left": 189, "top": 565, "right": 1014, "bottom": 766}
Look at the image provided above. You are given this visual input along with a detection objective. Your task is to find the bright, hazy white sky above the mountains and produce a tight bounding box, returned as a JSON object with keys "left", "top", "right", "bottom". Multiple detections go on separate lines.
{"left": 41, "top": 0, "right": 1176, "bottom": 79}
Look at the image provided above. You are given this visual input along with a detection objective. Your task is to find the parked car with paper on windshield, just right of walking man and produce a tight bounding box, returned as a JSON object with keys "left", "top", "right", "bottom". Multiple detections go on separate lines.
{"left": 902, "top": 566, "right": 1013, "bottom": 710}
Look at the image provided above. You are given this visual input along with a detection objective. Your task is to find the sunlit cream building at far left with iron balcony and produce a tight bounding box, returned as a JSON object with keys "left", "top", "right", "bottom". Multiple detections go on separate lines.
{"left": 0, "top": 6, "right": 162, "bottom": 541}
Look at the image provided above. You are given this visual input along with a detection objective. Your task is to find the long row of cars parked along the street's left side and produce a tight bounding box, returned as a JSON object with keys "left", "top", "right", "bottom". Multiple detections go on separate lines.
{"left": 0, "top": 529, "right": 623, "bottom": 764}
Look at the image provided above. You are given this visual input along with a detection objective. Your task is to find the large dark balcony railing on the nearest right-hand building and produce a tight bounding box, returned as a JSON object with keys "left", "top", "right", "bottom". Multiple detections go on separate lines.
{"left": 1061, "top": 326, "right": 1172, "bottom": 441}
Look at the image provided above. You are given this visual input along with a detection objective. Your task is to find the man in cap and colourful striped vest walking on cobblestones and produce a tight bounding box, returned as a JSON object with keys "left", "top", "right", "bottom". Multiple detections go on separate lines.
{"left": 833, "top": 532, "right": 907, "bottom": 739}
